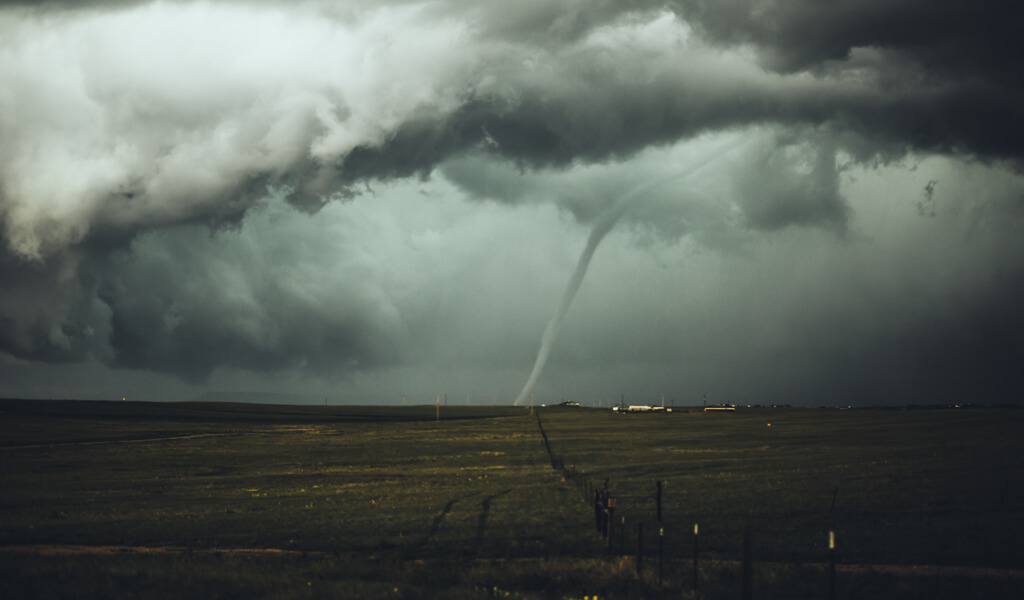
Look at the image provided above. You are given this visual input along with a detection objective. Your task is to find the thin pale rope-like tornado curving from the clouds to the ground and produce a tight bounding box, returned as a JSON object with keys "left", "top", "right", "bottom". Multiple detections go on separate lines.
{"left": 515, "top": 135, "right": 743, "bottom": 406}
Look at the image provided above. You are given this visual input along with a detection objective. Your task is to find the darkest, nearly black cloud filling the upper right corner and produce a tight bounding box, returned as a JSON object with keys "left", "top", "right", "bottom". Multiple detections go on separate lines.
{"left": 676, "top": 0, "right": 1024, "bottom": 160}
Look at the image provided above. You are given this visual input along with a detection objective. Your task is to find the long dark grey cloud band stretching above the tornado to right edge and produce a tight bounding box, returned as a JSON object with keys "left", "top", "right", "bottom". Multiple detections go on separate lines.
{"left": 319, "top": 23, "right": 1024, "bottom": 197}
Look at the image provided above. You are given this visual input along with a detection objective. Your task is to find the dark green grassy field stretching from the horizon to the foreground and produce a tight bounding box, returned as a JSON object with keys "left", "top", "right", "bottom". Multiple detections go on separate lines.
{"left": 0, "top": 401, "right": 1024, "bottom": 598}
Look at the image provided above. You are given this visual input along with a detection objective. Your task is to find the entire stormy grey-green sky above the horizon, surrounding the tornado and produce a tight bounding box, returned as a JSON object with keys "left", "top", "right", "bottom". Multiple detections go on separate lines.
{"left": 0, "top": 0, "right": 1024, "bottom": 405}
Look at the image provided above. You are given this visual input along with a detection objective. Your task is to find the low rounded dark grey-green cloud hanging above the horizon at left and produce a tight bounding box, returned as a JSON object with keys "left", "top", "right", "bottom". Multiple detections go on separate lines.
{"left": 97, "top": 217, "right": 401, "bottom": 382}
